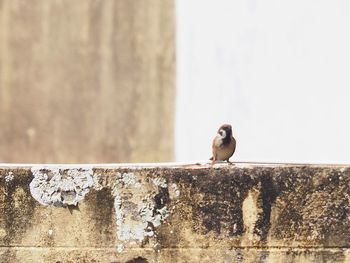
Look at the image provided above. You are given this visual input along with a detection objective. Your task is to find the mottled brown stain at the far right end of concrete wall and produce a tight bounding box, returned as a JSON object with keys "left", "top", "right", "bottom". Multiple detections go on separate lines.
{"left": 262, "top": 166, "right": 350, "bottom": 246}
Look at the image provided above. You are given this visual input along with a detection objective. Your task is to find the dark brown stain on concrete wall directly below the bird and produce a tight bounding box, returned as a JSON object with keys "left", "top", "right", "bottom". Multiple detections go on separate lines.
{"left": 170, "top": 169, "right": 256, "bottom": 236}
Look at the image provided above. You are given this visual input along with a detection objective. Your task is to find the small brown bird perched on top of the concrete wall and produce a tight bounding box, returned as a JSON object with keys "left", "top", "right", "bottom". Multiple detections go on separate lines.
{"left": 210, "top": 124, "right": 236, "bottom": 164}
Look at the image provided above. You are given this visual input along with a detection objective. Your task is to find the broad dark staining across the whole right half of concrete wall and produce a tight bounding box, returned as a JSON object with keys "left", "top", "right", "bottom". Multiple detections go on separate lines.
{"left": 164, "top": 166, "right": 350, "bottom": 248}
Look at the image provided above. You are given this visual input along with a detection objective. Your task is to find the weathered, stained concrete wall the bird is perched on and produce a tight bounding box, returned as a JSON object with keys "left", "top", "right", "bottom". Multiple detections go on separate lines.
{"left": 0, "top": 164, "right": 350, "bottom": 263}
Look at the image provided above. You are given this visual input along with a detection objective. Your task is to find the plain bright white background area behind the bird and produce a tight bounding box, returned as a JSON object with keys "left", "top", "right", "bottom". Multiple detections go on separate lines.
{"left": 176, "top": 0, "right": 350, "bottom": 163}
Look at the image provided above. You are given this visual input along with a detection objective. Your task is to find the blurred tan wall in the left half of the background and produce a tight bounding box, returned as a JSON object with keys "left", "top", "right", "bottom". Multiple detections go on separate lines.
{"left": 0, "top": 0, "right": 175, "bottom": 163}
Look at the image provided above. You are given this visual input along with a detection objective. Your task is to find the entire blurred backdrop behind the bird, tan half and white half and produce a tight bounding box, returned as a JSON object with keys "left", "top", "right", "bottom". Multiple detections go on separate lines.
{"left": 0, "top": 0, "right": 350, "bottom": 163}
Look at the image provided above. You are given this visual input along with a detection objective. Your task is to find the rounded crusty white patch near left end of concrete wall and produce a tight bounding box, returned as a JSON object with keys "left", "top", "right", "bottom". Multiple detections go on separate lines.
{"left": 30, "top": 166, "right": 94, "bottom": 206}
